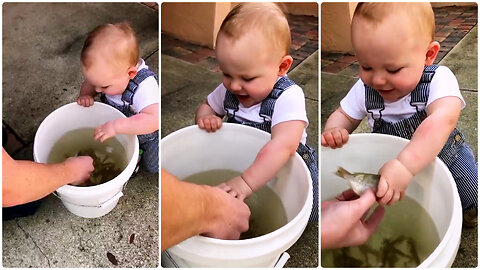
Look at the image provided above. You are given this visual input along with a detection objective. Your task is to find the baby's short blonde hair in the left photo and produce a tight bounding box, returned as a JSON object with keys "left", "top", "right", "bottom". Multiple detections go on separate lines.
{"left": 80, "top": 22, "right": 139, "bottom": 69}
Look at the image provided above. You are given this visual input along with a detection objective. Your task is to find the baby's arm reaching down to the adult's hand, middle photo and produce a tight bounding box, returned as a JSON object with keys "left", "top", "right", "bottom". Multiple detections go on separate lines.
{"left": 219, "top": 120, "right": 305, "bottom": 200}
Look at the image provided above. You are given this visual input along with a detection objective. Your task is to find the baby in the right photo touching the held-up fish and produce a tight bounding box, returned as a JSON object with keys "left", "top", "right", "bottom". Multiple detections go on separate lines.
{"left": 321, "top": 3, "right": 478, "bottom": 226}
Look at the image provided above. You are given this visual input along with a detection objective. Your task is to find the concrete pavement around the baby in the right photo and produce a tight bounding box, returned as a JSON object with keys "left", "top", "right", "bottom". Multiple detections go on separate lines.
{"left": 321, "top": 26, "right": 478, "bottom": 267}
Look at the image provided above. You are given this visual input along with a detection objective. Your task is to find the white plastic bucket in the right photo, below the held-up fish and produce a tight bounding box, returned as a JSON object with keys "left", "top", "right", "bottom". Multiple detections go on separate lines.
{"left": 321, "top": 134, "right": 462, "bottom": 268}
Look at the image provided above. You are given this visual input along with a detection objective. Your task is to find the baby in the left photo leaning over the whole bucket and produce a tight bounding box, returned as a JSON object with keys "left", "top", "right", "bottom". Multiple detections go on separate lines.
{"left": 77, "top": 23, "right": 159, "bottom": 173}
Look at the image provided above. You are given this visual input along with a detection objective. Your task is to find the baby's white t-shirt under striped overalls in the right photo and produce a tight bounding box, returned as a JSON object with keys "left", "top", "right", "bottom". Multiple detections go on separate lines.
{"left": 340, "top": 66, "right": 465, "bottom": 130}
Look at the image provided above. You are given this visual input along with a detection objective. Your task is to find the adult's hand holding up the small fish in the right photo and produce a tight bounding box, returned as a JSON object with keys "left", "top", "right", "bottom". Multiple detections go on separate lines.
{"left": 321, "top": 190, "right": 385, "bottom": 249}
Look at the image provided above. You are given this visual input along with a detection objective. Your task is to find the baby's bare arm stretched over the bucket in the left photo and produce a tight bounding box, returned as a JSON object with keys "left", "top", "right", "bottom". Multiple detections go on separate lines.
{"left": 94, "top": 103, "right": 158, "bottom": 142}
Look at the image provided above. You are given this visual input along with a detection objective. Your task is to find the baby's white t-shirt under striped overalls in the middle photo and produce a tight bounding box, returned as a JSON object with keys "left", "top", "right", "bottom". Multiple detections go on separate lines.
{"left": 207, "top": 77, "right": 308, "bottom": 144}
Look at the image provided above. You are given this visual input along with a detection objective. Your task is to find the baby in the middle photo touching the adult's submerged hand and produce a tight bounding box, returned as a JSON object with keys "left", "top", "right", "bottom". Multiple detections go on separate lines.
{"left": 195, "top": 3, "right": 318, "bottom": 221}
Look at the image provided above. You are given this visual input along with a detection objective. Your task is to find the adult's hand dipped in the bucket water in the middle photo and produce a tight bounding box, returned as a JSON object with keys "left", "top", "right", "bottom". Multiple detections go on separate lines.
{"left": 202, "top": 187, "right": 250, "bottom": 240}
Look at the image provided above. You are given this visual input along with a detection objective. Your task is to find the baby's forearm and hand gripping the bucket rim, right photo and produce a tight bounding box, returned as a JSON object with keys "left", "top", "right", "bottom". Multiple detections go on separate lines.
{"left": 321, "top": 107, "right": 361, "bottom": 148}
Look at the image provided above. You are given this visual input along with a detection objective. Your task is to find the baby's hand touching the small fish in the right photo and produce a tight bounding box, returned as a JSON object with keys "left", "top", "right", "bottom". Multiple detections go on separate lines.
{"left": 377, "top": 159, "right": 413, "bottom": 205}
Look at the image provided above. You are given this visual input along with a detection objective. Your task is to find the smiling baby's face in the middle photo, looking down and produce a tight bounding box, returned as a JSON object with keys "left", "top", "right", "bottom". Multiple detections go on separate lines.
{"left": 215, "top": 31, "right": 283, "bottom": 107}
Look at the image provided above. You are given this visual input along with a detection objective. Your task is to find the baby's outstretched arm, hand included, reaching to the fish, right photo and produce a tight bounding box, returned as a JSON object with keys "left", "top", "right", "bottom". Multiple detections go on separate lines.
{"left": 377, "top": 97, "right": 462, "bottom": 205}
